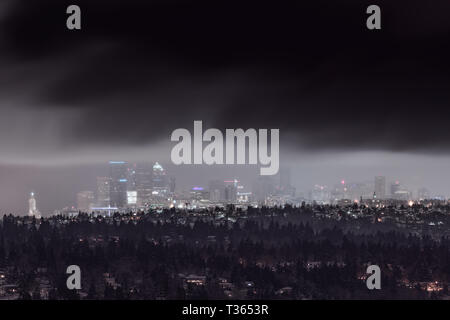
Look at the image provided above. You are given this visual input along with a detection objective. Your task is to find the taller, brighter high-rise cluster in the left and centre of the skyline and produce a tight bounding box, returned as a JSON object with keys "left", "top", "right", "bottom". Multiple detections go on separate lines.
{"left": 70, "top": 161, "right": 302, "bottom": 215}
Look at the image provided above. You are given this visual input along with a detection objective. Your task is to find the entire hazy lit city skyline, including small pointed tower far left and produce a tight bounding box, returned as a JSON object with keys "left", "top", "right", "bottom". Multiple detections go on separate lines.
{"left": 15, "top": 160, "right": 447, "bottom": 216}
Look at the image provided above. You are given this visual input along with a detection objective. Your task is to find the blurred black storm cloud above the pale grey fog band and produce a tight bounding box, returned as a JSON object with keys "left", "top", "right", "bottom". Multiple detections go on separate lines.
{"left": 0, "top": 0, "right": 450, "bottom": 152}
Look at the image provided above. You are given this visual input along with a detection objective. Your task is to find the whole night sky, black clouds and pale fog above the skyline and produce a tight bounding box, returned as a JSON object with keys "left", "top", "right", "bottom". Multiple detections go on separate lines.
{"left": 0, "top": 0, "right": 450, "bottom": 214}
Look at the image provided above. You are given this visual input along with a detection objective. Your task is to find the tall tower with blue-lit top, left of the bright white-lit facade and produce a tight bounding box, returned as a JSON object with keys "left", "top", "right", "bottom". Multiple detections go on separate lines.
{"left": 109, "top": 161, "right": 128, "bottom": 208}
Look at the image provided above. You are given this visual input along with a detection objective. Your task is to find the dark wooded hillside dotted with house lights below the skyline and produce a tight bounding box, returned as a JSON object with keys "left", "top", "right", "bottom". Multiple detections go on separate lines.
{"left": 0, "top": 208, "right": 450, "bottom": 299}
